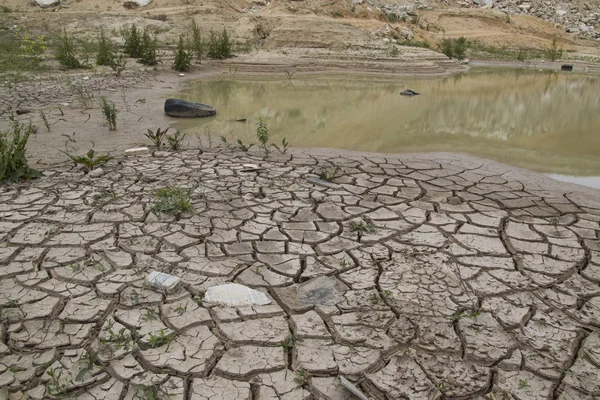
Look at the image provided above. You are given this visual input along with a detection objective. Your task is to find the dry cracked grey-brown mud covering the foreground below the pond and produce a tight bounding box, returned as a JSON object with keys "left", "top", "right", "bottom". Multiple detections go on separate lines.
{"left": 0, "top": 150, "right": 600, "bottom": 400}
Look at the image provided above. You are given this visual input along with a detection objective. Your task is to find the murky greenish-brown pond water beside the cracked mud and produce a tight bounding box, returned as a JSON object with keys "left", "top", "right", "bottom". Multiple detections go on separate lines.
{"left": 178, "top": 70, "right": 600, "bottom": 176}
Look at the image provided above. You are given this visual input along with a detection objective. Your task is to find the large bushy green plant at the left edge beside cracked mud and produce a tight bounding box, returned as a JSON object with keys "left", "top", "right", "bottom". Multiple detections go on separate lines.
{"left": 0, "top": 116, "right": 41, "bottom": 183}
